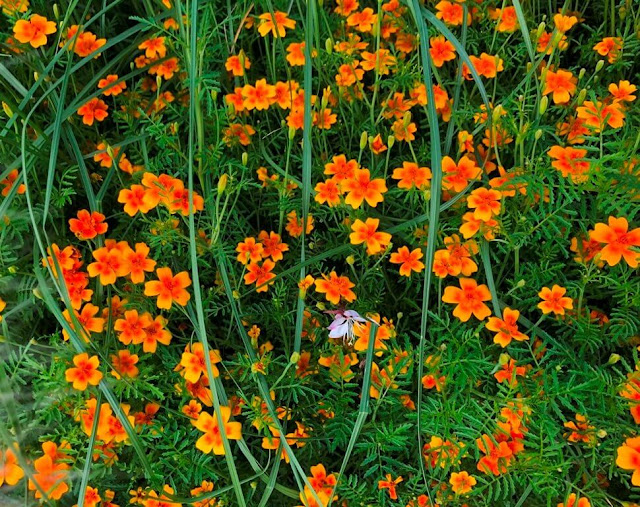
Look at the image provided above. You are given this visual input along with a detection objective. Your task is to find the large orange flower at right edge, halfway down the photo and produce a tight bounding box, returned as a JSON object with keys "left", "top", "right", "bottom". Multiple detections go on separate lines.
{"left": 589, "top": 217, "right": 640, "bottom": 269}
